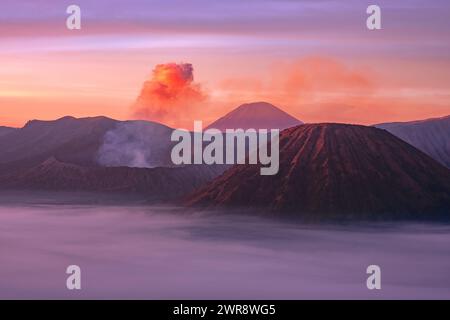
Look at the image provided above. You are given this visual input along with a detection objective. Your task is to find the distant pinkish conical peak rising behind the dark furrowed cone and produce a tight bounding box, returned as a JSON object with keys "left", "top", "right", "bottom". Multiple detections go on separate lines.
{"left": 207, "top": 102, "right": 302, "bottom": 131}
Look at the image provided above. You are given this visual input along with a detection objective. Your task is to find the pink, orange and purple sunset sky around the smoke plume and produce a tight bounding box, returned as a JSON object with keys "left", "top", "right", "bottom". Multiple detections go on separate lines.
{"left": 0, "top": 0, "right": 450, "bottom": 126}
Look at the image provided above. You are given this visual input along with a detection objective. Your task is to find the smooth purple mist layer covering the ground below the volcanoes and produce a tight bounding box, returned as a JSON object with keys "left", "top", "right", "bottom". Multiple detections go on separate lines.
{"left": 0, "top": 203, "right": 450, "bottom": 299}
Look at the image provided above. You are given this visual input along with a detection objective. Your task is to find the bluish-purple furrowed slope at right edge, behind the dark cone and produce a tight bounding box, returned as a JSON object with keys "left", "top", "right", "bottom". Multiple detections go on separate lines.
{"left": 375, "top": 116, "right": 450, "bottom": 168}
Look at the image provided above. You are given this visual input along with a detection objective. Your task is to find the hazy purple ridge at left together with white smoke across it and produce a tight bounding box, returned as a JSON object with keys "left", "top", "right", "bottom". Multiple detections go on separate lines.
{"left": 0, "top": 117, "right": 172, "bottom": 176}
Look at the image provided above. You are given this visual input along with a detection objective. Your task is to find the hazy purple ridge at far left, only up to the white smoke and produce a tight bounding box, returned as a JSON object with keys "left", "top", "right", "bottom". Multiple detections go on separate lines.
{"left": 0, "top": 117, "right": 118, "bottom": 175}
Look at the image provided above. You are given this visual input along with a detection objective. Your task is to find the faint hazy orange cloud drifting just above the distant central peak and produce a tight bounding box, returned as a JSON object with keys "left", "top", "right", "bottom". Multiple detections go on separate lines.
{"left": 221, "top": 57, "right": 375, "bottom": 102}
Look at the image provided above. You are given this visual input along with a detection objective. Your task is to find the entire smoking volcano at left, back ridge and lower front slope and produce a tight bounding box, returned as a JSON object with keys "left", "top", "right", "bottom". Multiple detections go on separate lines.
{"left": 0, "top": 116, "right": 226, "bottom": 200}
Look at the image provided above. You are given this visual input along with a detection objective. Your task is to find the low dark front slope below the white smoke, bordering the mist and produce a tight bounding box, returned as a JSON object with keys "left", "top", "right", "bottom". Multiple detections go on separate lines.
{"left": 0, "top": 158, "right": 224, "bottom": 200}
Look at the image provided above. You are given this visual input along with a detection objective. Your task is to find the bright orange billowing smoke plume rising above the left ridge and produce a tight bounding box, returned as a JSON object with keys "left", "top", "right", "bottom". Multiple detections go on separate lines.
{"left": 132, "top": 63, "right": 207, "bottom": 126}
